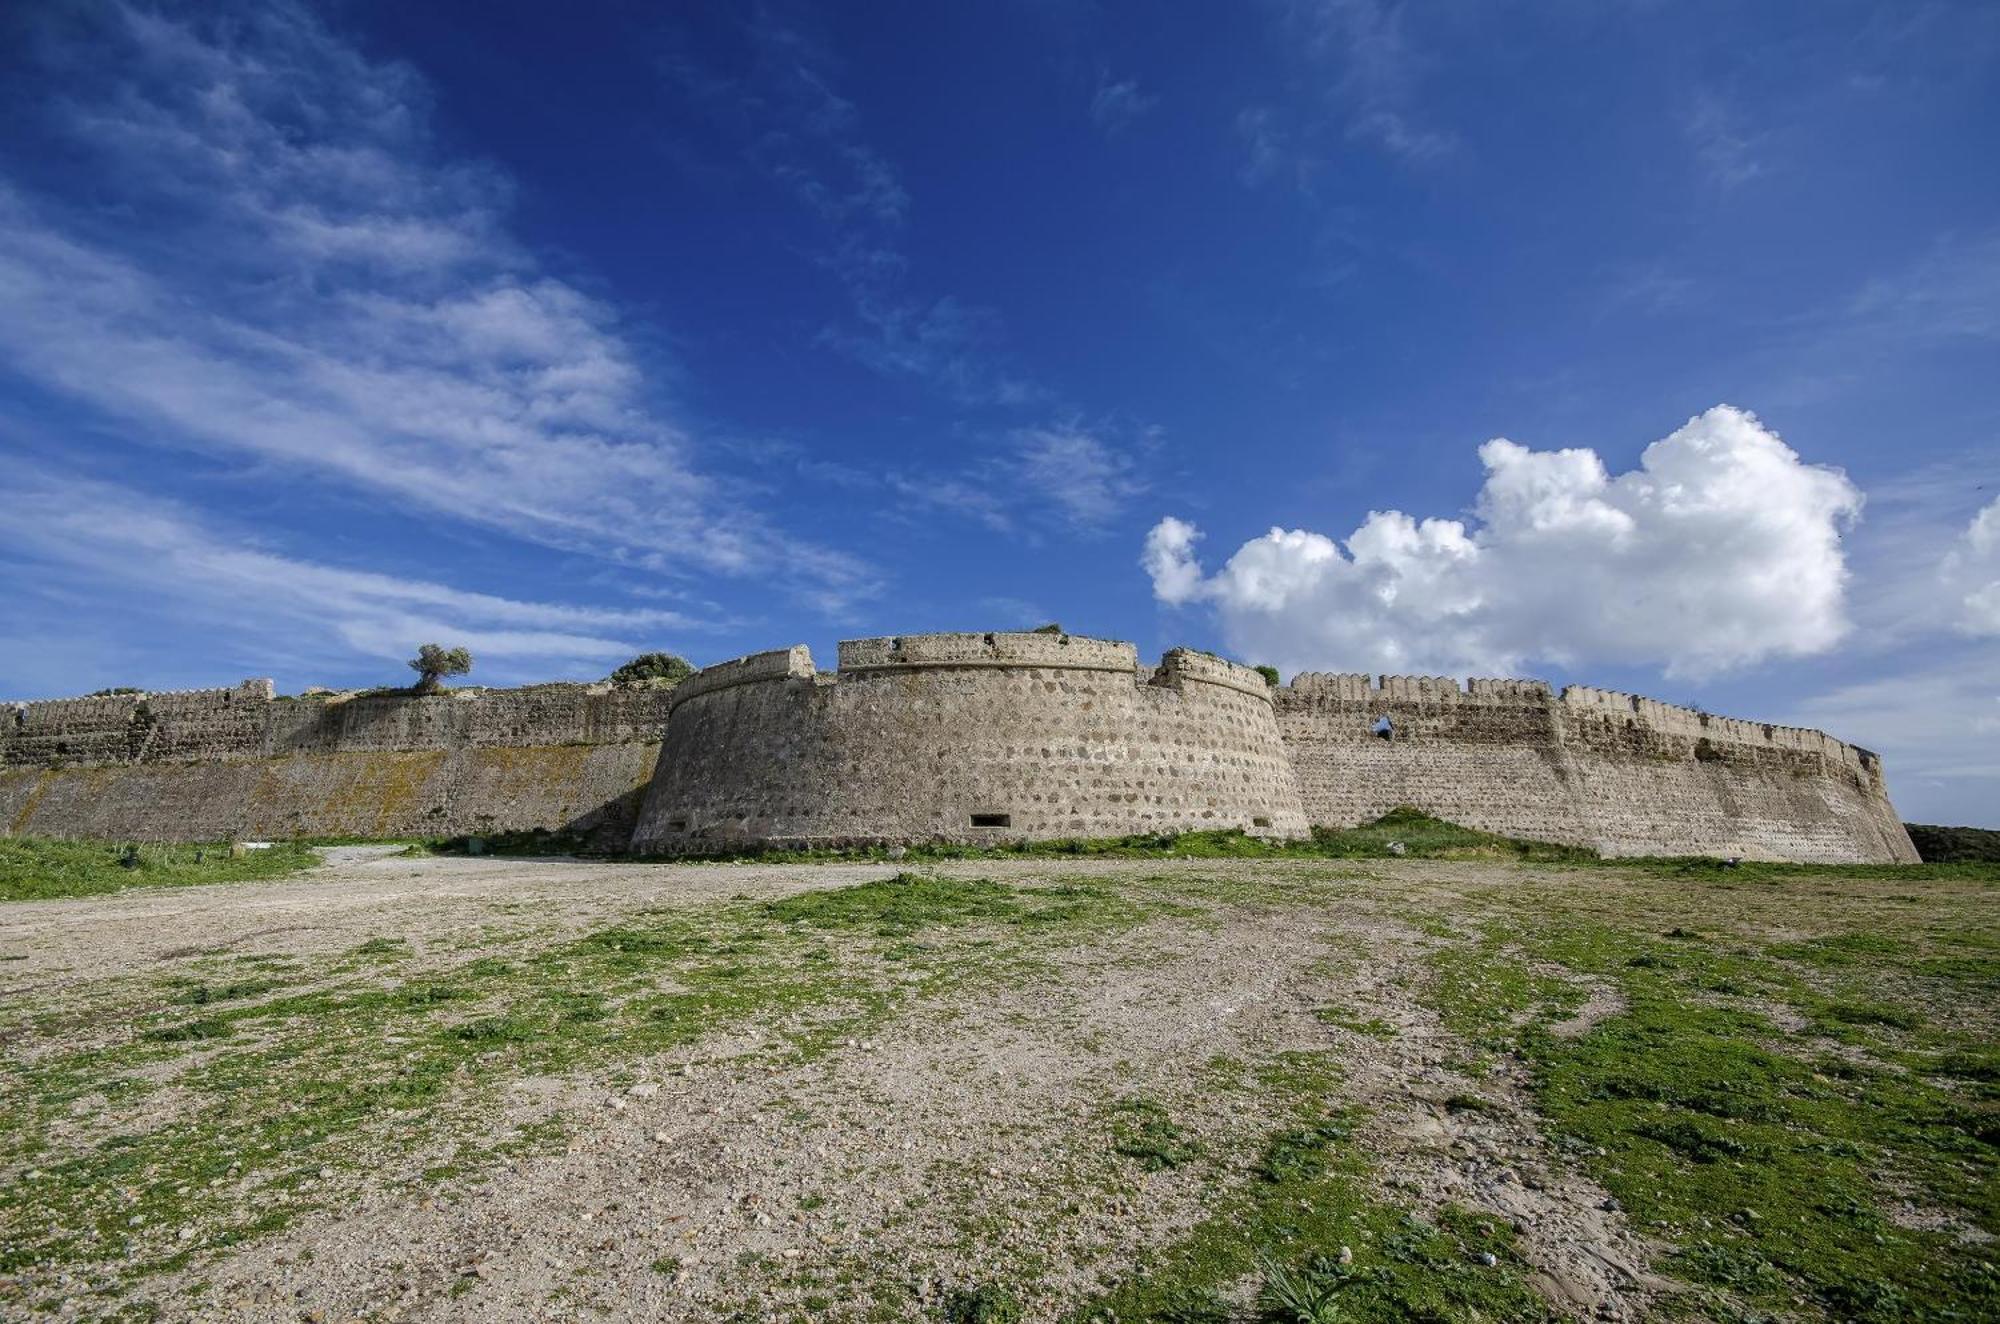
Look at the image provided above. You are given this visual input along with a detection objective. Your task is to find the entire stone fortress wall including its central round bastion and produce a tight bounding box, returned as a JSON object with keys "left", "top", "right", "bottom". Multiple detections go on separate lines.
{"left": 0, "top": 634, "right": 1916, "bottom": 862}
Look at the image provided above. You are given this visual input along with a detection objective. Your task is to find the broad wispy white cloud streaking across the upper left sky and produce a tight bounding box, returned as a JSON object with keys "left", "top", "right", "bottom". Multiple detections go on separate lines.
{"left": 0, "top": 4, "right": 874, "bottom": 600}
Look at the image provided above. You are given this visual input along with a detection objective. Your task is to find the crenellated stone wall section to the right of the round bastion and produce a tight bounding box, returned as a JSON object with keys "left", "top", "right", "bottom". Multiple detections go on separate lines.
{"left": 1274, "top": 672, "right": 1916, "bottom": 862}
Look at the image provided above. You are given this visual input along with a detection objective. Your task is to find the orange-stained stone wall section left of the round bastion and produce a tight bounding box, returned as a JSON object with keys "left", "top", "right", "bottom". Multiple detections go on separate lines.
{"left": 0, "top": 680, "right": 668, "bottom": 844}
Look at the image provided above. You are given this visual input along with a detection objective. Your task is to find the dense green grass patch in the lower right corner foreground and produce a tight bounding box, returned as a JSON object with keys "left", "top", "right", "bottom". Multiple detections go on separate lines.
{"left": 1428, "top": 920, "right": 2000, "bottom": 1324}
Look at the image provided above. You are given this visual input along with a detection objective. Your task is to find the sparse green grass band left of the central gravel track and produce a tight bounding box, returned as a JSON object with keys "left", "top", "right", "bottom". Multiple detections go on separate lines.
{"left": 0, "top": 874, "right": 1170, "bottom": 1284}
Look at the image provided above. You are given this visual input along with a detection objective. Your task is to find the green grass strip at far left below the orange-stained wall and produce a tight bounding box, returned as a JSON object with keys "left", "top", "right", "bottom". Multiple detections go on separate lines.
{"left": 0, "top": 836, "right": 320, "bottom": 902}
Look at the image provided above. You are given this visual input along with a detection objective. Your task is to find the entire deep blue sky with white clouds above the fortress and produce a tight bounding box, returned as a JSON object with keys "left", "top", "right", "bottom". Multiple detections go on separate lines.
{"left": 0, "top": 0, "right": 2000, "bottom": 826}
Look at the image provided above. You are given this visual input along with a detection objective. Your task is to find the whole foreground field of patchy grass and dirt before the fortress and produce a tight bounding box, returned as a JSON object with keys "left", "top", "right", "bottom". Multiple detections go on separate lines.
{"left": 0, "top": 820, "right": 2000, "bottom": 1324}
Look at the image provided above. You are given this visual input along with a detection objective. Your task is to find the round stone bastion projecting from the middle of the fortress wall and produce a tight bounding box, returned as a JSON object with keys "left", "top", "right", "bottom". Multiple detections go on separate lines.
{"left": 632, "top": 634, "right": 1306, "bottom": 854}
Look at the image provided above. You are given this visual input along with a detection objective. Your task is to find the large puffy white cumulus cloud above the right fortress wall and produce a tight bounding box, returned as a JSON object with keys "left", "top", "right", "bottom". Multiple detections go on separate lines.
{"left": 1142, "top": 404, "right": 1862, "bottom": 676}
